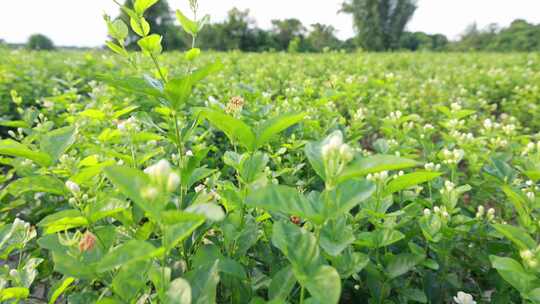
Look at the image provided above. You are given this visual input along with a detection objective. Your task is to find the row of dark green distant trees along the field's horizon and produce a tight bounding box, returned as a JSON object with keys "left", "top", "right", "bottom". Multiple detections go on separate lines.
{"left": 10, "top": 0, "right": 540, "bottom": 52}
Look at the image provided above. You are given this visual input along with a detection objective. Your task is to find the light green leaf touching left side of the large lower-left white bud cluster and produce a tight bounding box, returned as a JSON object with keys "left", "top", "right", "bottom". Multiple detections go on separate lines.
{"left": 104, "top": 166, "right": 160, "bottom": 219}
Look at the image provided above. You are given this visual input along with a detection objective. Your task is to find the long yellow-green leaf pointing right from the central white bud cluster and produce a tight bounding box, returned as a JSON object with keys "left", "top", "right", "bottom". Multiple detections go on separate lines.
{"left": 339, "top": 155, "right": 420, "bottom": 181}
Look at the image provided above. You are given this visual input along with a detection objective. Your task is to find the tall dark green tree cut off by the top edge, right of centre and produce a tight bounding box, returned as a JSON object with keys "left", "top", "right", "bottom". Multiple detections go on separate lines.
{"left": 341, "top": 0, "right": 417, "bottom": 51}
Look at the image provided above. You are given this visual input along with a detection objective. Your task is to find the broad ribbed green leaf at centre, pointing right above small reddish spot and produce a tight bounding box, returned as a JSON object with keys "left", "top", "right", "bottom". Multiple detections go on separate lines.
{"left": 246, "top": 184, "right": 322, "bottom": 222}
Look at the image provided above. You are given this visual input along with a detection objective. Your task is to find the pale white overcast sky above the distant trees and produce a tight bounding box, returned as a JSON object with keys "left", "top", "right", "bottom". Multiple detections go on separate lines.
{"left": 0, "top": 0, "right": 540, "bottom": 46}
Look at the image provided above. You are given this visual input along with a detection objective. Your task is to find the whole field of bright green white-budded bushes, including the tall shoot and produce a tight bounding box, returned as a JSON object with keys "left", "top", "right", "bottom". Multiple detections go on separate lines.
{"left": 0, "top": 0, "right": 540, "bottom": 304}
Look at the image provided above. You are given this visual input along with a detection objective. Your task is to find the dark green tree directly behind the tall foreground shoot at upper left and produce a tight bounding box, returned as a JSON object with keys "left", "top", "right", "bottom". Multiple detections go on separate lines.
{"left": 119, "top": 0, "right": 190, "bottom": 50}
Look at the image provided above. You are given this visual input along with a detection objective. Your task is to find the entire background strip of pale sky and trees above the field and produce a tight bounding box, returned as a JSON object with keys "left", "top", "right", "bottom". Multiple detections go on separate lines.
{"left": 0, "top": 0, "right": 540, "bottom": 52}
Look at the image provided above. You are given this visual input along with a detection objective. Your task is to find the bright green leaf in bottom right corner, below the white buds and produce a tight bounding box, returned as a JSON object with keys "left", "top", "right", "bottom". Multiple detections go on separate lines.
{"left": 489, "top": 255, "right": 536, "bottom": 293}
